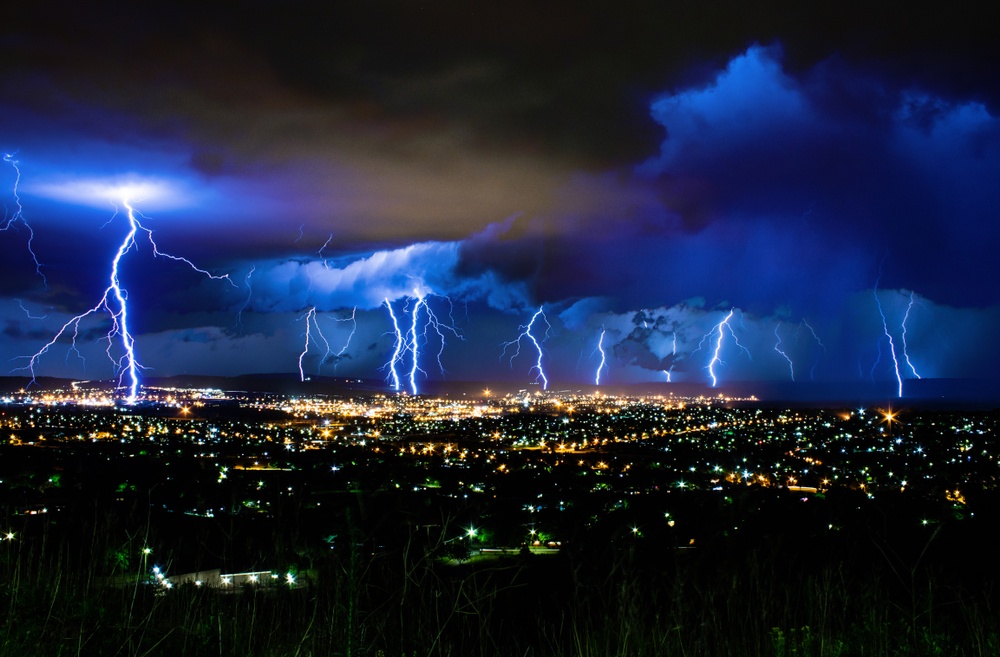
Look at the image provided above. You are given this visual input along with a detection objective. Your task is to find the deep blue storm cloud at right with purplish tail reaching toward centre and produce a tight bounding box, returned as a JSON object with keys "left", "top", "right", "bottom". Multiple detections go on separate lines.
{"left": 452, "top": 47, "right": 1000, "bottom": 314}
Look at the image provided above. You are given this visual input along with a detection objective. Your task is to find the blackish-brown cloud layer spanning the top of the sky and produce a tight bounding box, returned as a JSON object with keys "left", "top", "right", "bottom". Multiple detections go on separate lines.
{"left": 4, "top": 2, "right": 996, "bottom": 258}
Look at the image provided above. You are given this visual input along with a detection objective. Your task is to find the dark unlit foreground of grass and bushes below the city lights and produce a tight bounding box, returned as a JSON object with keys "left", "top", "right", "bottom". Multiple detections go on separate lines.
{"left": 0, "top": 482, "right": 1000, "bottom": 657}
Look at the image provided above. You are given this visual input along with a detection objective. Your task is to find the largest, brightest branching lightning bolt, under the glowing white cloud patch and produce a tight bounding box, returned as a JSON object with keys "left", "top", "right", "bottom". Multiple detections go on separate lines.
{"left": 19, "top": 198, "right": 236, "bottom": 404}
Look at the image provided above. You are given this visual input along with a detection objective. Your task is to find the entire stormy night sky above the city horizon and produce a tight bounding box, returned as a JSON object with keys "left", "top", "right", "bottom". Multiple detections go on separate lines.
{"left": 0, "top": 0, "right": 1000, "bottom": 388}
